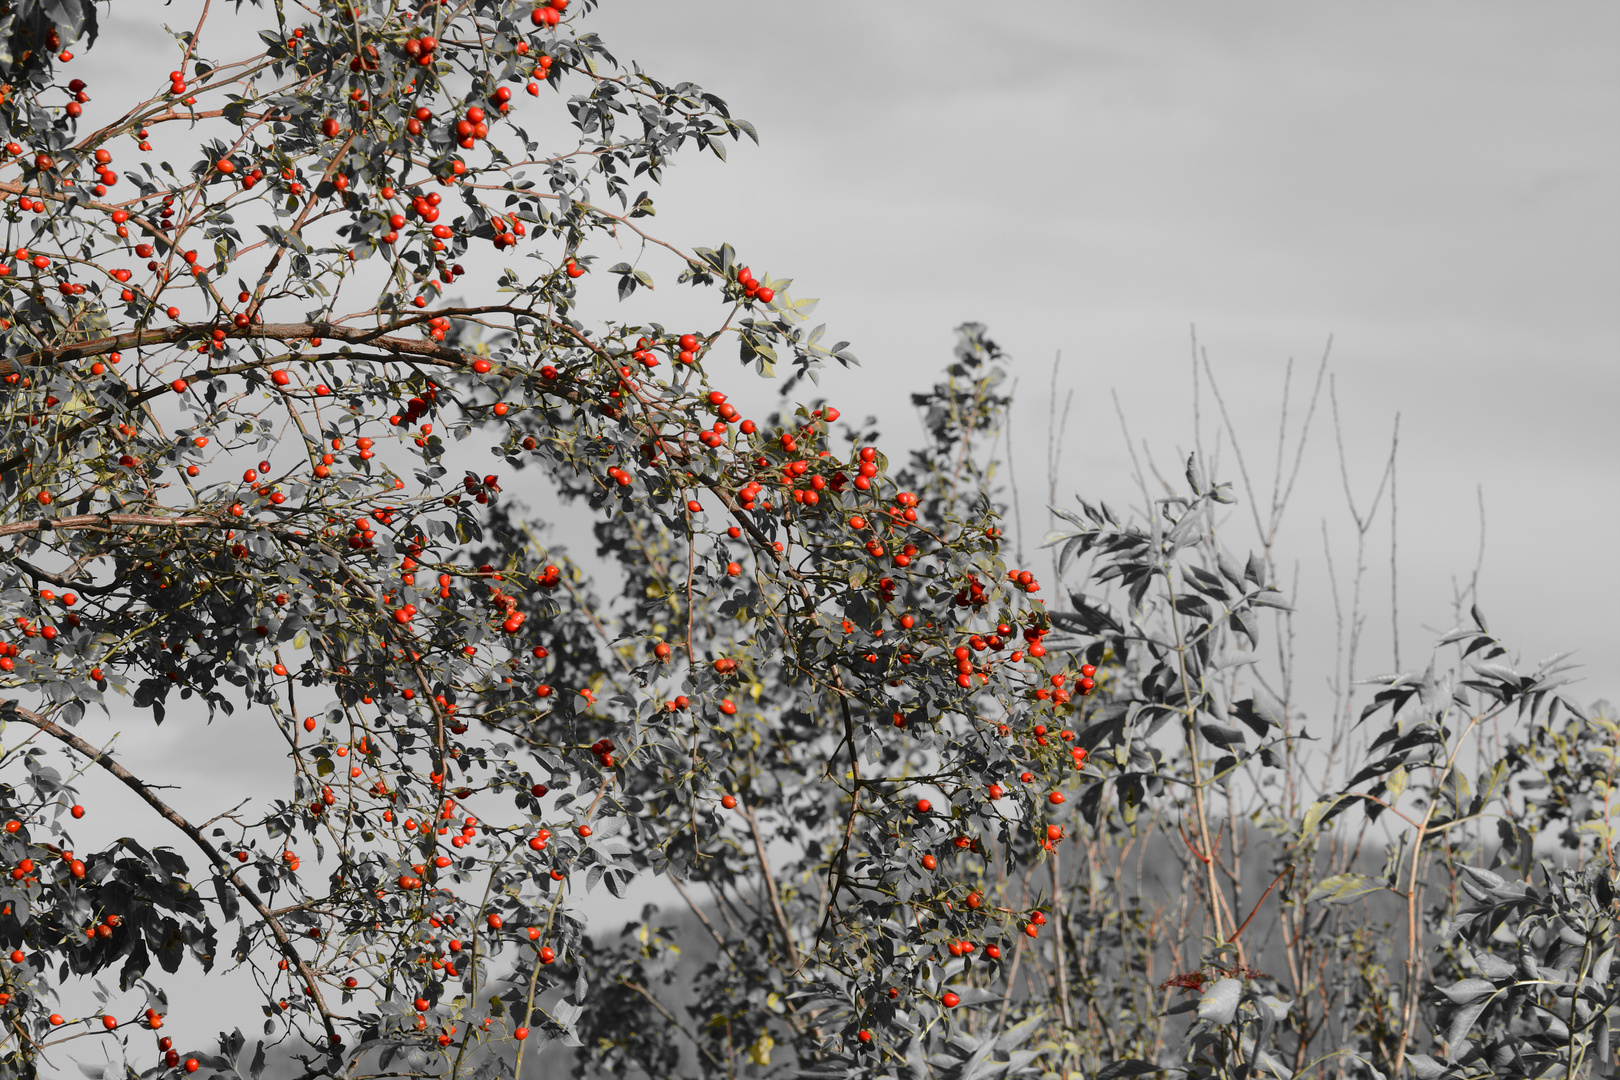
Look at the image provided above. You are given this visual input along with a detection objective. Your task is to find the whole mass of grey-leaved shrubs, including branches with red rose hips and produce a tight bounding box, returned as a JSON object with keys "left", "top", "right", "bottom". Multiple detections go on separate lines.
{"left": 0, "top": 0, "right": 1620, "bottom": 1080}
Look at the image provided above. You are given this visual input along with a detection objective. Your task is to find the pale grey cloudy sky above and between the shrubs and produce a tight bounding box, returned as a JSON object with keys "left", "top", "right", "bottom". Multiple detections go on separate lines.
{"left": 34, "top": 0, "right": 1620, "bottom": 1075}
